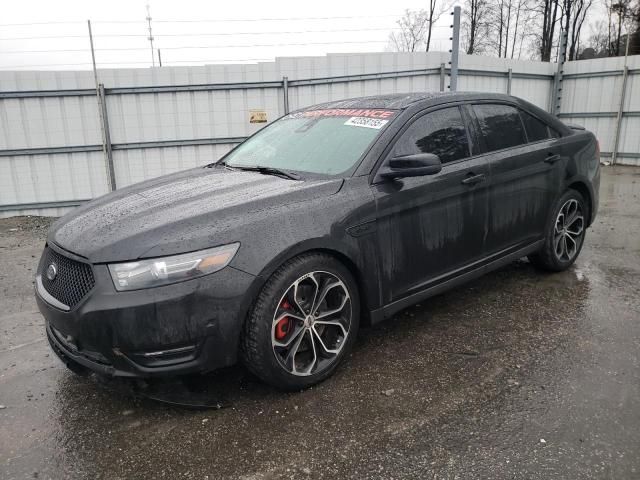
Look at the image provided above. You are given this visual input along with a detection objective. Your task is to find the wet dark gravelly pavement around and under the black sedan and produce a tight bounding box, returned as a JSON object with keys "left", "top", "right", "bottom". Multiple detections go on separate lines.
{"left": 0, "top": 167, "right": 640, "bottom": 479}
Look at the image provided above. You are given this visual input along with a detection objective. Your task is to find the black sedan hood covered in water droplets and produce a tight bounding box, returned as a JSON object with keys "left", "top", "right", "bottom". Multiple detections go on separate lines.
{"left": 48, "top": 168, "right": 342, "bottom": 263}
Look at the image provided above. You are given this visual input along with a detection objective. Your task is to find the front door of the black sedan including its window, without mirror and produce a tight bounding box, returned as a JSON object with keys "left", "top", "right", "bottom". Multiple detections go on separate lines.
{"left": 372, "top": 106, "right": 490, "bottom": 303}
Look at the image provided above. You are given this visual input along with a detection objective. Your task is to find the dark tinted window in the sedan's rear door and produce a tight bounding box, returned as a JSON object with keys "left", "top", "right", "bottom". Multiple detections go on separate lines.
{"left": 473, "top": 104, "right": 527, "bottom": 152}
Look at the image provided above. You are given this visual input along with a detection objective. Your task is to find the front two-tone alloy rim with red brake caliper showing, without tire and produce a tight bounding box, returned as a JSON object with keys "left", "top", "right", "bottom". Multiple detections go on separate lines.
{"left": 271, "top": 271, "right": 353, "bottom": 376}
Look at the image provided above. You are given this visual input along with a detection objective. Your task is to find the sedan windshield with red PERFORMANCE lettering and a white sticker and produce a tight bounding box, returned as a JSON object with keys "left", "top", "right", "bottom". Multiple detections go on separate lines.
{"left": 223, "top": 109, "right": 396, "bottom": 175}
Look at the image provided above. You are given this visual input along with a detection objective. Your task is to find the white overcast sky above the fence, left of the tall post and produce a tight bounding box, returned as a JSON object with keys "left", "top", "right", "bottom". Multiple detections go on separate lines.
{"left": 0, "top": 0, "right": 451, "bottom": 70}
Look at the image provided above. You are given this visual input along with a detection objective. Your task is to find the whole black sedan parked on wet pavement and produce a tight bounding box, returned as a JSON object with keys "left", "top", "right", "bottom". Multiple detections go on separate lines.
{"left": 36, "top": 93, "right": 600, "bottom": 389}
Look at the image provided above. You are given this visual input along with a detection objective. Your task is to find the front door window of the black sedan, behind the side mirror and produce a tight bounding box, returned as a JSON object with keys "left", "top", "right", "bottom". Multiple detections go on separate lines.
{"left": 393, "top": 107, "right": 469, "bottom": 163}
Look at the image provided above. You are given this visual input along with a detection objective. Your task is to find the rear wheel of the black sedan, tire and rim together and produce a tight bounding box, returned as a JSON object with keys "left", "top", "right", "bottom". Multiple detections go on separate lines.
{"left": 529, "top": 189, "right": 589, "bottom": 272}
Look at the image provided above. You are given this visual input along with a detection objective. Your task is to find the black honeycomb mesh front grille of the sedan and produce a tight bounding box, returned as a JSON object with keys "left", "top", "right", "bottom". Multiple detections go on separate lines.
{"left": 38, "top": 247, "right": 96, "bottom": 308}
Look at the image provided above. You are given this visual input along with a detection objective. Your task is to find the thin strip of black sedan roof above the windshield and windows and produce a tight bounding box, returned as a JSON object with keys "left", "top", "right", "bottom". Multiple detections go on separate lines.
{"left": 302, "top": 92, "right": 518, "bottom": 110}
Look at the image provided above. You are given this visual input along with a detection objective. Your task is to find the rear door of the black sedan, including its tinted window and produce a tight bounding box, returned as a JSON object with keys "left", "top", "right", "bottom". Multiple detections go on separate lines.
{"left": 471, "top": 103, "right": 563, "bottom": 253}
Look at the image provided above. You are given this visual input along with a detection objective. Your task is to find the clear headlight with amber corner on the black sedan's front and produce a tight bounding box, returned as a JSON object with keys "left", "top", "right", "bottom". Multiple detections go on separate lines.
{"left": 109, "top": 243, "right": 240, "bottom": 291}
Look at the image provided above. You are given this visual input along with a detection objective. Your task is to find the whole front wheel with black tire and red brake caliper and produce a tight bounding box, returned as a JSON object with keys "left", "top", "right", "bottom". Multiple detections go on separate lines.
{"left": 240, "top": 253, "right": 360, "bottom": 390}
